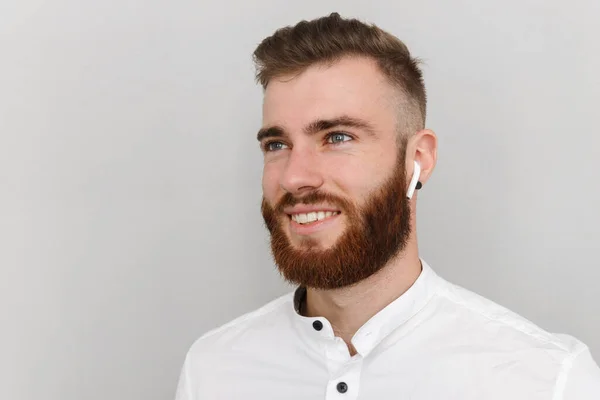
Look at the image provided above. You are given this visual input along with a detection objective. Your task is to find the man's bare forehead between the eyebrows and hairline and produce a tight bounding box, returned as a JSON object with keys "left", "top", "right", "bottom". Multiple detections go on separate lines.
{"left": 263, "top": 57, "right": 398, "bottom": 129}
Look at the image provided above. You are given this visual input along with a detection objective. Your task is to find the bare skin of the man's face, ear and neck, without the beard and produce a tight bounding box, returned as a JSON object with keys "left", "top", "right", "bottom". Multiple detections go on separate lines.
{"left": 261, "top": 57, "right": 437, "bottom": 354}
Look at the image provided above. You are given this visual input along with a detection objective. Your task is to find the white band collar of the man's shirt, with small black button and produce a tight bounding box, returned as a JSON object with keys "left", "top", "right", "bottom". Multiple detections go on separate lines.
{"left": 293, "top": 259, "right": 440, "bottom": 357}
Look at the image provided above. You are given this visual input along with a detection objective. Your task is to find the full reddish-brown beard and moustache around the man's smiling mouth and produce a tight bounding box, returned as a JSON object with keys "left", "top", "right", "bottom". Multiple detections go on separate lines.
{"left": 261, "top": 146, "right": 411, "bottom": 289}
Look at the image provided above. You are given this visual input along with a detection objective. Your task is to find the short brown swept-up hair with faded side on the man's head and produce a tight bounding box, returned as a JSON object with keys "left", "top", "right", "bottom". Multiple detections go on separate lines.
{"left": 253, "top": 13, "right": 427, "bottom": 134}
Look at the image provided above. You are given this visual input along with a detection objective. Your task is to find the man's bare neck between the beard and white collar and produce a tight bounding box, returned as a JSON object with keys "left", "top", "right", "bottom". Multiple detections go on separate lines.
{"left": 305, "top": 245, "right": 422, "bottom": 355}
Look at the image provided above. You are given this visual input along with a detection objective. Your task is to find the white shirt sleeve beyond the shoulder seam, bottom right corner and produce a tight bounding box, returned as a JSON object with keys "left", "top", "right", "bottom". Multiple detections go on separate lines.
{"left": 554, "top": 347, "right": 600, "bottom": 400}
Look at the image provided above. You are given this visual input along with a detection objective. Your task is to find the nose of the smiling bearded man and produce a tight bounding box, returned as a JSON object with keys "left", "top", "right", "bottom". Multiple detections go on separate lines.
{"left": 280, "top": 147, "right": 323, "bottom": 195}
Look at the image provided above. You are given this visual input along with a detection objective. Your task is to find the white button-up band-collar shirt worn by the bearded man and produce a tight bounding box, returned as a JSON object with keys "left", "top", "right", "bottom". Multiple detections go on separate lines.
{"left": 176, "top": 262, "right": 600, "bottom": 400}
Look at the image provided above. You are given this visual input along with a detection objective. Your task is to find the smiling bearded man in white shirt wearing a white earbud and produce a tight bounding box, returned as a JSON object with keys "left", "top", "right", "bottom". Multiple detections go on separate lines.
{"left": 177, "top": 14, "right": 600, "bottom": 400}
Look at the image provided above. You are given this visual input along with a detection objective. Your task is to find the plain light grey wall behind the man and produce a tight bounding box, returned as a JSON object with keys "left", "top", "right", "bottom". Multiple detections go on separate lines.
{"left": 0, "top": 0, "right": 600, "bottom": 400}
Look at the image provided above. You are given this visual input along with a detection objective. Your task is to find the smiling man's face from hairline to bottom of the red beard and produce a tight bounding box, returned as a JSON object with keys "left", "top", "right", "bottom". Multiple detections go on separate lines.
{"left": 259, "top": 58, "right": 410, "bottom": 289}
